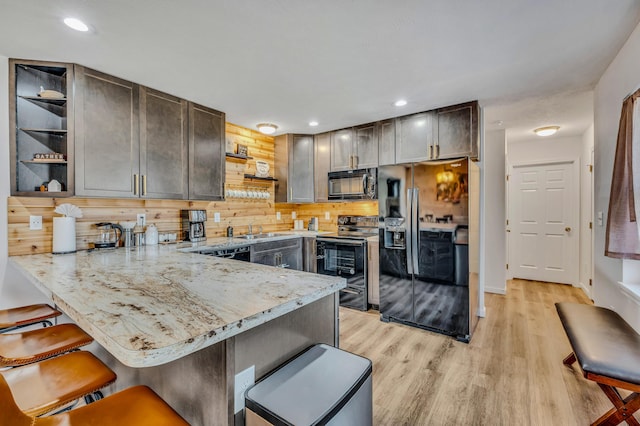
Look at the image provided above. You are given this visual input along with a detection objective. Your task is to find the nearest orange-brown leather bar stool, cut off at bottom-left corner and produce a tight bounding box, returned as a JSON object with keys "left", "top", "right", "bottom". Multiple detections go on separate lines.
{"left": 0, "top": 375, "right": 189, "bottom": 426}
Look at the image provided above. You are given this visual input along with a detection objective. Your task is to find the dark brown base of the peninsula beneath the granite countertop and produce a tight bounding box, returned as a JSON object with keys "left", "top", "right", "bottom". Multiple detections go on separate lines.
{"left": 95, "top": 294, "right": 339, "bottom": 426}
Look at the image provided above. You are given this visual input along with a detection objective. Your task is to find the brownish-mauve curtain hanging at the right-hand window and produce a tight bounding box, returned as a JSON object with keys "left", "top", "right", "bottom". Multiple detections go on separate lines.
{"left": 605, "top": 90, "right": 640, "bottom": 260}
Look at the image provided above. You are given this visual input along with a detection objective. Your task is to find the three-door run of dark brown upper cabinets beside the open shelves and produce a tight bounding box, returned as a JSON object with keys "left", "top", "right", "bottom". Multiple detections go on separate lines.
{"left": 76, "top": 66, "right": 220, "bottom": 200}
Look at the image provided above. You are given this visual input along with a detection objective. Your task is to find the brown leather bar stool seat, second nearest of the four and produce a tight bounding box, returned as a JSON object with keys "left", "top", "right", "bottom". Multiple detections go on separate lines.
{"left": 0, "top": 351, "right": 116, "bottom": 416}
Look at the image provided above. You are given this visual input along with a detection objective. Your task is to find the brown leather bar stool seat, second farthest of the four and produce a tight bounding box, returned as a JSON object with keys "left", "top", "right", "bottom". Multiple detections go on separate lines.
{"left": 0, "top": 324, "right": 93, "bottom": 368}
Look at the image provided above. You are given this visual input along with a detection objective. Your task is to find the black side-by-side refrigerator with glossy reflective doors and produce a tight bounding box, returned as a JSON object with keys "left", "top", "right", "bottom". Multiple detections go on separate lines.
{"left": 378, "top": 158, "right": 480, "bottom": 342}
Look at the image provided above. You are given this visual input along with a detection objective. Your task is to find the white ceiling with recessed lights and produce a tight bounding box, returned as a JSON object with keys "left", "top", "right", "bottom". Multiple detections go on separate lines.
{"left": 0, "top": 0, "right": 640, "bottom": 140}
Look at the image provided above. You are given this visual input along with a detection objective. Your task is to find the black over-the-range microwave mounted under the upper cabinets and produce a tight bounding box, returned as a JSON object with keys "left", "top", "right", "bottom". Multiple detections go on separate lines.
{"left": 329, "top": 168, "right": 378, "bottom": 200}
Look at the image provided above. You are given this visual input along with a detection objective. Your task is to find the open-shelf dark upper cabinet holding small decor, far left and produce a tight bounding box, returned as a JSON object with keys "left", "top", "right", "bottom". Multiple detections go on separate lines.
{"left": 9, "top": 59, "right": 74, "bottom": 197}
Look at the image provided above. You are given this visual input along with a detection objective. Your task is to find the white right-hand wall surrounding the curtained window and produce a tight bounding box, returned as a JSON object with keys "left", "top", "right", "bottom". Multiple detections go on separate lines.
{"left": 593, "top": 20, "right": 640, "bottom": 329}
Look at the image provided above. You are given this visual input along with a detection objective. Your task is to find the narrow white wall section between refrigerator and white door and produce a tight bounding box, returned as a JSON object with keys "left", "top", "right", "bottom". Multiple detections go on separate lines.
{"left": 481, "top": 130, "right": 507, "bottom": 294}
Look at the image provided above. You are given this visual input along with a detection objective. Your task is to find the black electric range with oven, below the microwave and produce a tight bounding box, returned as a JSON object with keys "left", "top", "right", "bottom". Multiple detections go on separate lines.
{"left": 316, "top": 216, "right": 378, "bottom": 311}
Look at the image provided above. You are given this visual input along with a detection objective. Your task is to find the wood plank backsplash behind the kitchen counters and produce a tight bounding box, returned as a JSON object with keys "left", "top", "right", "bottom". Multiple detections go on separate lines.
{"left": 7, "top": 123, "right": 378, "bottom": 256}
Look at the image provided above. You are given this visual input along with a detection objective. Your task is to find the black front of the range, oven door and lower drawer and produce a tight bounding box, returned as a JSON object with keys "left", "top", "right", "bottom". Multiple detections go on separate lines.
{"left": 316, "top": 237, "right": 368, "bottom": 311}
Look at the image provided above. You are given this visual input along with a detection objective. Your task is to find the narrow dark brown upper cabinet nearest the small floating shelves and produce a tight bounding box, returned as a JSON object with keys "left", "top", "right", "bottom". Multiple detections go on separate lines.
{"left": 189, "top": 102, "right": 226, "bottom": 200}
